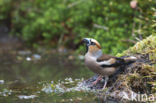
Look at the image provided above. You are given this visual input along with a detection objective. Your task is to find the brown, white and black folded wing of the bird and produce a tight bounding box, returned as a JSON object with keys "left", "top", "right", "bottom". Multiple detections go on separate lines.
{"left": 96, "top": 54, "right": 124, "bottom": 67}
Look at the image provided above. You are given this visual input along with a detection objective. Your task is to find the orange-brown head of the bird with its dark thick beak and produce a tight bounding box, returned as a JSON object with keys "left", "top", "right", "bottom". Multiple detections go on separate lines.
{"left": 82, "top": 38, "right": 101, "bottom": 53}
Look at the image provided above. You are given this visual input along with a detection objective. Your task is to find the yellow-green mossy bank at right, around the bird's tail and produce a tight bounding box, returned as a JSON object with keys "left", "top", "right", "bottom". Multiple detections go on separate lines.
{"left": 114, "top": 35, "right": 156, "bottom": 93}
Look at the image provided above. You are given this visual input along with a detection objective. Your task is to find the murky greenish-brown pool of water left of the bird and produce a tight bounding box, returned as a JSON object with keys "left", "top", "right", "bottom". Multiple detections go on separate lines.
{"left": 0, "top": 51, "right": 98, "bottom": 103}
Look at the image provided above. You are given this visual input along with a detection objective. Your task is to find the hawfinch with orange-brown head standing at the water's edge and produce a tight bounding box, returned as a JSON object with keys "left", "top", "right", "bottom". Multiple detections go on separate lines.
{"left": 82, "top": 38, "right": 137, "bottom": 89}
